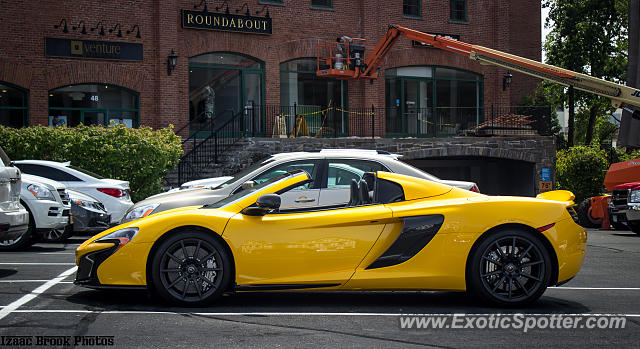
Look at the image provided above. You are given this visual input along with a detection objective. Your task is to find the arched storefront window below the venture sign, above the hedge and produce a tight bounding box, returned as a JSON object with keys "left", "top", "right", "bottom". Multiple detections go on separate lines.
{"left": 49, "top": 84, "right": 140, "bottom": 127}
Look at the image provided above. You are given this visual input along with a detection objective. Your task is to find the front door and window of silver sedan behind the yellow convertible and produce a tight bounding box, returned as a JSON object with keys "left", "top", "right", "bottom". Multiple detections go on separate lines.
{"left": 251, "top": 159, "right": 321, "bottom": 209}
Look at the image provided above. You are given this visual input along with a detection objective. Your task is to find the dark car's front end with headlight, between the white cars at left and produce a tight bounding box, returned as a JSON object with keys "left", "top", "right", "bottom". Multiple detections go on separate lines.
{"left": 43, "top": 189, "right": 111, "bottom": 241}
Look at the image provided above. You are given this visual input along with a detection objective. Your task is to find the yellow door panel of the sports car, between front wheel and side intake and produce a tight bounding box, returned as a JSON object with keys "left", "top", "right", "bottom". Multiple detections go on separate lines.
{"left": 223, "top": 205, "right": 392, "bottom": 288}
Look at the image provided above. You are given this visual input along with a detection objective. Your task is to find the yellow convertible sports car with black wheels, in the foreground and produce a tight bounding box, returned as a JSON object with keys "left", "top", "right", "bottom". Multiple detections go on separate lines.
{"left": 75, "top": 170, "right": 587, "bottom": 305}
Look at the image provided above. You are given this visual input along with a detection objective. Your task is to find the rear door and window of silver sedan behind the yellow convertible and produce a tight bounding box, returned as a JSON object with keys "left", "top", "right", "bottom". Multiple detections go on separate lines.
{"left": 319, "top": 159, "right": 388, "bottom": 206}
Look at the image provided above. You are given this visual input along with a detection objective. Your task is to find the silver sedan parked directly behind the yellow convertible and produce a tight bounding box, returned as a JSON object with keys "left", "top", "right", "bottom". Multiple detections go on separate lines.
{"left": 122, "top": 149, "right": 478, "bottom": 223}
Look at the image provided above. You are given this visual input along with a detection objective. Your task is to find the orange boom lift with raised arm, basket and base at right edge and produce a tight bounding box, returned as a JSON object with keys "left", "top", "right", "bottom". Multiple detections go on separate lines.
{"left": 316, "top": 25, "right": 640, "bottom": 234}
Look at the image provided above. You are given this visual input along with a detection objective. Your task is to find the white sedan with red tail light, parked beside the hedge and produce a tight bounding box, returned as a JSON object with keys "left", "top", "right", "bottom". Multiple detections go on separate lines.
{"left": 14, "top": 160, "right": 133, "bottom": 224}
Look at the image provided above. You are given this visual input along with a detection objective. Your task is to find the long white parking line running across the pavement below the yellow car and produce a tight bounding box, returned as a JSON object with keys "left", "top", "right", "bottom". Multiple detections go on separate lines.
{"left": 0, "top": 309, "right": 640, "bottom": 318}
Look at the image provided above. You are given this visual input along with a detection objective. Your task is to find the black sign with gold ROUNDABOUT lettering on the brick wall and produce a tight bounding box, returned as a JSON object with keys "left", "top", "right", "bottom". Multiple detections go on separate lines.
{"left": 182, "top": 10, "right": 271, "bottom": 34}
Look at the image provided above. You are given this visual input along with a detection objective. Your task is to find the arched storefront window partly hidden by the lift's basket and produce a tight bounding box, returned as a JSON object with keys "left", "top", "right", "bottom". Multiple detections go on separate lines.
{"left": 280, "top": 58, "right": 348, "bottom": 134}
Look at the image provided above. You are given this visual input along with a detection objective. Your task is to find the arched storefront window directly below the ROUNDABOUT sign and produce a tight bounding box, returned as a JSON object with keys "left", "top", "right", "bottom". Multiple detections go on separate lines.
{"left": 189, "top": 52, "right": 264, "bottom": 133}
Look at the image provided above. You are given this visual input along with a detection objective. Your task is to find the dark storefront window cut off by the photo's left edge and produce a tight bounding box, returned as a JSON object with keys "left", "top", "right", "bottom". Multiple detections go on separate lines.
{"left": 0, "top": 81, "right": 29, "bottom": 128}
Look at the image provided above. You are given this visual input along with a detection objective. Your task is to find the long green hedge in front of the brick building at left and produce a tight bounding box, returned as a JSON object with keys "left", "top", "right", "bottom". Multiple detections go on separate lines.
{"left": 0, "top": 125, "right": 182, "bottom": 201}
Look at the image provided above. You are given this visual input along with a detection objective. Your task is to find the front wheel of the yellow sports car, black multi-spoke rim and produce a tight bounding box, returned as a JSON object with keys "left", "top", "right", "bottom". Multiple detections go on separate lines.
{"left": 150, "top": 229, "right": 233, "bottom": 306}
